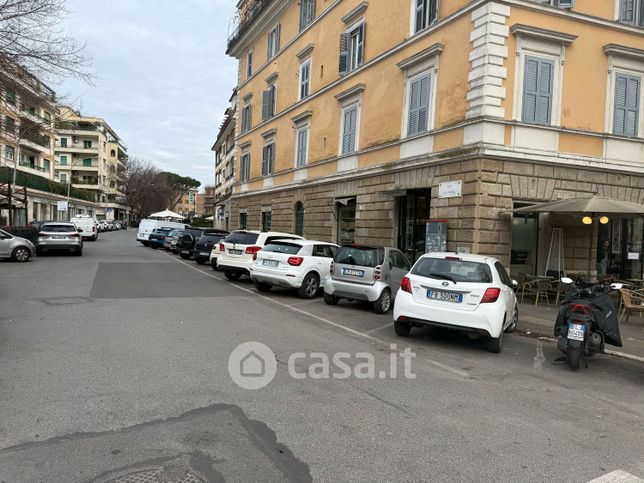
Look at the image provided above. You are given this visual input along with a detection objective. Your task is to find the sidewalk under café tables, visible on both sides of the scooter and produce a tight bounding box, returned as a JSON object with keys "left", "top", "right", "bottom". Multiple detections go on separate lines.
{"left": 517, "top": 304, "right": 644, "bottom": 362}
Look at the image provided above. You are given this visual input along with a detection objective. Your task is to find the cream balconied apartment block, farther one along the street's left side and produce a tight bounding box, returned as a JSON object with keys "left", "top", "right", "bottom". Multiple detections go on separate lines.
{"left": 54, "top": 107, "right": 129, "bottom": 220}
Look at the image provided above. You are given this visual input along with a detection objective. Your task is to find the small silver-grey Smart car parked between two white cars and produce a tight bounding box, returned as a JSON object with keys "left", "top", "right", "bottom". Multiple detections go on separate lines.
{"left": 324, "top": 245, "right": 411, "bottom": 314}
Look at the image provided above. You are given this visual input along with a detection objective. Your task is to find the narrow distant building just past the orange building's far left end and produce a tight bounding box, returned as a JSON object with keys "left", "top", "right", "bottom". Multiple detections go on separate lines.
{"left": 212, "top": 92, "right": 237, "bottom": 230}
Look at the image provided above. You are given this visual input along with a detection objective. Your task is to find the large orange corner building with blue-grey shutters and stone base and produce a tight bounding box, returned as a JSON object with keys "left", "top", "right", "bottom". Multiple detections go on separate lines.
{"left": 227, "top": 0, "right": 644, "bottom": 276}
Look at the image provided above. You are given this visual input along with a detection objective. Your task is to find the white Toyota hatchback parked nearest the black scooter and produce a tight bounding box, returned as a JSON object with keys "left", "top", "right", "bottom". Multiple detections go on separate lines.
{"left": 394, "top": 253, "right": 519, "bottom": 353}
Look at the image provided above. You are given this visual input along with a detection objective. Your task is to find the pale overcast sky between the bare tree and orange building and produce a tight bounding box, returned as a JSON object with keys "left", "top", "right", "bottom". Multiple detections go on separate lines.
{"left": 57, "top": 0, "right": 237, "bottom": 190}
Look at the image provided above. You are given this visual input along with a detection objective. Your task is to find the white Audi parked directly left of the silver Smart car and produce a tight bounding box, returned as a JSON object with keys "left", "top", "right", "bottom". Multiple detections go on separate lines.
{"left": 250, "top": 240, "right": 340, "bottom": 299}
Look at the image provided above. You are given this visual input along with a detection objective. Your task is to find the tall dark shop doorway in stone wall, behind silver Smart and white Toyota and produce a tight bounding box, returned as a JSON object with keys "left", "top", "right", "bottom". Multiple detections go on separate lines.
{"left": 398, "top": 190, "right": 431, "bottom": 263}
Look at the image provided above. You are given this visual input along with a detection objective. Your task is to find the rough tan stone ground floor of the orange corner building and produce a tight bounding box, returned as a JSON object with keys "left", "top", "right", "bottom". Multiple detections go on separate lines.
{"left": 230, "top": 156, "right": 644, "bottom": 278}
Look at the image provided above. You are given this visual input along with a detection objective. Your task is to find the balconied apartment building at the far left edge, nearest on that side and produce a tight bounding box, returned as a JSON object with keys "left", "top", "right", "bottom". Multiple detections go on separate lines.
{"left": 0, "top": 63, "right": 97, "bottom": 225}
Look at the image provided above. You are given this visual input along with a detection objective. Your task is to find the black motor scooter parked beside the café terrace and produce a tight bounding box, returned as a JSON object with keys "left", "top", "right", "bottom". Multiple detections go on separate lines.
{"left": 555, "top": 278, "right": 622, "bottom": 371}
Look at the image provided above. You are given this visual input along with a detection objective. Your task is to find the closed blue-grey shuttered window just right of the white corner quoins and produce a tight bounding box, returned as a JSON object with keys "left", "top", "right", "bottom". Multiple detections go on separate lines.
{"left": 521, "top": 56, "right": 554, "bottom": 124}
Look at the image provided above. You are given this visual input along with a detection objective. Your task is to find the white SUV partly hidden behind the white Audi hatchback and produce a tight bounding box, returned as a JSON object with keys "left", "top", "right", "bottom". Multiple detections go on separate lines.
{"left": 217, "top": 230, "right": 302, "bottom": 280}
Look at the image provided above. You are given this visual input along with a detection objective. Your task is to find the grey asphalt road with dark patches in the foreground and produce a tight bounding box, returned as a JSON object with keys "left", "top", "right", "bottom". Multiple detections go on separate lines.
{"left": 0, "top": 230, "right": 644, "bottom": 483}
